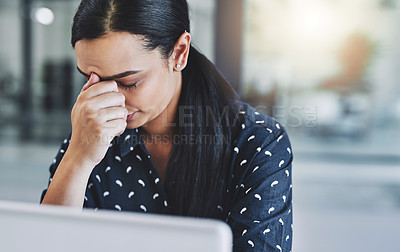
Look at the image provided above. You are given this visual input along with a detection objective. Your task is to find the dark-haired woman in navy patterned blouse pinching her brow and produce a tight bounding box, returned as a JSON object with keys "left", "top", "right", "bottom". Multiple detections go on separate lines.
{"left": 41, "top": 0, "right": 292, "bottom": 251}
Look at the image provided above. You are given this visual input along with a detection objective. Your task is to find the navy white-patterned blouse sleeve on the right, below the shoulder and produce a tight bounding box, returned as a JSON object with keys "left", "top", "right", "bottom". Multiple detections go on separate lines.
{"left": 227, "top": 128, "right": 293, "bottom": 252}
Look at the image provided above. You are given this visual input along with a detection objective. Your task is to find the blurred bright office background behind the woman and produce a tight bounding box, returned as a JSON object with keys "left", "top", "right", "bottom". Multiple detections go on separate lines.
{"left": 0, "top": 0, "right": 400, "bottom": 252}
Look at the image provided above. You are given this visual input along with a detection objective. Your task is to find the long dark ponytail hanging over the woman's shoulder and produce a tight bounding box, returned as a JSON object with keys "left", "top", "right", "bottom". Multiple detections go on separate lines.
{"left": 166, "top": 46, "right": 239, "bottom": 220}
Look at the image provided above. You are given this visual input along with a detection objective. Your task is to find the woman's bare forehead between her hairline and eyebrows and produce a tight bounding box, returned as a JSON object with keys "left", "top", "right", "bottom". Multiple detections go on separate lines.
{"left": 75, "top": 32, "right": 161, "bottom": 76}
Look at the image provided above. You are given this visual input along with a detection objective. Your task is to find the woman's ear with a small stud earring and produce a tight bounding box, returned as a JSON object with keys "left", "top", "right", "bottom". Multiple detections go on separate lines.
{"left": 172, "top": 31, "right": 192, "bottom": 72}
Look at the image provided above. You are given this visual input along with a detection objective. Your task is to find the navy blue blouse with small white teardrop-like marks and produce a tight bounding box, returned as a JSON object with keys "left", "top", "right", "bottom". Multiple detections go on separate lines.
{"left": 40, "top": 103, "right": 293, "bottom": 252}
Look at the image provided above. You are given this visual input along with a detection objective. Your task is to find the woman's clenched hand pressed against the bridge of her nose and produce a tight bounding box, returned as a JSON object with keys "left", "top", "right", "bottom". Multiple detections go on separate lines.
{"left": 69, "top": 73, "right": 128, "bottom": 169}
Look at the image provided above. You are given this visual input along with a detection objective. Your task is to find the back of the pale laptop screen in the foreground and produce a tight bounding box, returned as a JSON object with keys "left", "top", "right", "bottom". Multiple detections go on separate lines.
{"left": 0, "top": 201, "right": 232, "bottom": 252}
